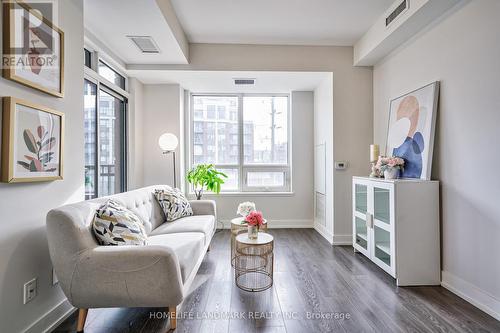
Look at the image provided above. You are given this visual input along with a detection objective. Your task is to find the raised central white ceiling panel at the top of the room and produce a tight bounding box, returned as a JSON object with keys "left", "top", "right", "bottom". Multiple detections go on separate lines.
{"left": 171, "top": 0, "right": 394, "bottom": 46}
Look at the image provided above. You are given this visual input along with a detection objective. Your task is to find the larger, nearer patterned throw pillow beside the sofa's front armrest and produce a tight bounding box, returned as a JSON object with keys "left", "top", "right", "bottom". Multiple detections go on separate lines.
{"left": 92, "top": 200, "right": 148, "bottom": 245}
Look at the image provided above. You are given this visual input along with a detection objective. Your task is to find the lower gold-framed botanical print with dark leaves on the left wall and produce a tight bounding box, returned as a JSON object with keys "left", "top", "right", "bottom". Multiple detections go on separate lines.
{"left": 1, "top": 97, "right": 64, "bottom": 183}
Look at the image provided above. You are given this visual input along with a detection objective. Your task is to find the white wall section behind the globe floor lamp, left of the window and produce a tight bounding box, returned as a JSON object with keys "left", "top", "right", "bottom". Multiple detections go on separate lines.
{"left": 142, "top": 84, "right": 184, "bottom": 186}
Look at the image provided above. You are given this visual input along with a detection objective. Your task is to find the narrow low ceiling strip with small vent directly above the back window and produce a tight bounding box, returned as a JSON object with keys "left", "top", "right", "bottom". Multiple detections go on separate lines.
{"left": 129, "top": 70, "right": 331, "bottom": 93}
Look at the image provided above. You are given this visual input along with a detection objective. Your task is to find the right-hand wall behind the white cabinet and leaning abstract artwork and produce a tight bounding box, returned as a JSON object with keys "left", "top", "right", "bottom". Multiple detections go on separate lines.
{"left": 373, "top": 0, "right": 500, "bottom": 319}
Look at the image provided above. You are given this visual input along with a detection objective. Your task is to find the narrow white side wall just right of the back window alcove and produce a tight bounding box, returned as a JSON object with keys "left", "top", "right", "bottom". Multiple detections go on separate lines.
{"left": 314, "top": 74, "right": 334, "bottom": 239}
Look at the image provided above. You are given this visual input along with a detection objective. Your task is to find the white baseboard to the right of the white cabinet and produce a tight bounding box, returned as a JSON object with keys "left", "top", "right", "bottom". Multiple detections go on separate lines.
{"left": 441, "top": 271, "right": 500, "bottom": 320}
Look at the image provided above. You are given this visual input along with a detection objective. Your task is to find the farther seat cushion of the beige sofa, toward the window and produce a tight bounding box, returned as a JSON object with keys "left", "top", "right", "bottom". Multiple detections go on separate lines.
{"left": 150, "top": 215, "right": 215, "bottom": 242}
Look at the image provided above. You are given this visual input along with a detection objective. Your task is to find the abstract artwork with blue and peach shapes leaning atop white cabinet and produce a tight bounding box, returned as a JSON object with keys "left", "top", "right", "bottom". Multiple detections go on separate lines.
{"left": 386, "top": 82, "right": 439, "bottom": 180}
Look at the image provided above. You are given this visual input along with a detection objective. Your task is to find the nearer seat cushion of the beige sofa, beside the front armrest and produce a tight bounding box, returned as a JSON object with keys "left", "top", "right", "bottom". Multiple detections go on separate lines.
{"left": 148, "top": 232, "right": 205, "bottom": 282}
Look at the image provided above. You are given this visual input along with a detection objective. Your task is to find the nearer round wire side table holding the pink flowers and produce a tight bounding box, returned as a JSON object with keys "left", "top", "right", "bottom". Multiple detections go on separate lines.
{"left": 234, "top": 232, "right": 274, "bottom": 291}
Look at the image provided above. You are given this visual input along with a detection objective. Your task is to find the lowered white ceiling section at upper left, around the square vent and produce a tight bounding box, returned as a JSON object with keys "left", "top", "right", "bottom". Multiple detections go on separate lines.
{"left": 84, "top": 0, "right": 187, "bottom": 64}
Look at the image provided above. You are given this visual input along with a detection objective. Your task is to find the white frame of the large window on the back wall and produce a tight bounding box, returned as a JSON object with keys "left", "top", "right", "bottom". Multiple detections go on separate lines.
{"left": 186, "top": 93, "right": 293, "bottom": 195}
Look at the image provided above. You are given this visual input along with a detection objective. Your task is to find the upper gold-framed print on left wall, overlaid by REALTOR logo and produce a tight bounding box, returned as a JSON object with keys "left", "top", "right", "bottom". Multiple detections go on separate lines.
{"left": 2, "top": 0, "right": 64, "bottom": 97}
